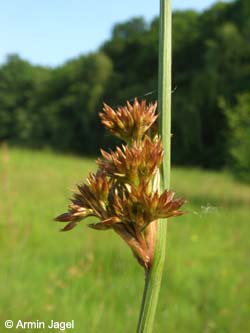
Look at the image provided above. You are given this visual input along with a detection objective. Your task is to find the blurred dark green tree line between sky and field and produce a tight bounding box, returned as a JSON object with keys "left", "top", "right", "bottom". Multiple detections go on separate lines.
{"left": 0, "top": 0, "right": 250, "bottom": 181}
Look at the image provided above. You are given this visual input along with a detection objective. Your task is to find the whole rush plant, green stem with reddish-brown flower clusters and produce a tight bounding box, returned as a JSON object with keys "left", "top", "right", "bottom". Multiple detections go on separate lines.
{"left": 55, "top": 0, "right": 182, "bottom": 333}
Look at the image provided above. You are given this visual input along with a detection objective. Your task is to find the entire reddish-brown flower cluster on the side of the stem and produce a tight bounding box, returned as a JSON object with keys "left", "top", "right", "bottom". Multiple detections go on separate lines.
{"left": 55, "top": 99, "right": 185, "bottom": 269}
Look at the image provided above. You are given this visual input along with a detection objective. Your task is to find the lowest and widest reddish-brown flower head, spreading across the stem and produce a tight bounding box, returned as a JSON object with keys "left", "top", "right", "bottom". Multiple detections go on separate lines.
{"left": 56, "top": 171, "right": 184, "bottom": 231}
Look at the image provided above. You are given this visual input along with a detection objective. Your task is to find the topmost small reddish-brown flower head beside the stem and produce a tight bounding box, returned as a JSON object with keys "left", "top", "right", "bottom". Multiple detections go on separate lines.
{"left": 99, "top": 99, "right": 157, "bottom": 142}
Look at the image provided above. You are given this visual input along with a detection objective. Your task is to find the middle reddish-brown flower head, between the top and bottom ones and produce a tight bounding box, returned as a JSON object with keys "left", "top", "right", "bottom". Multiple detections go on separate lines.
{"left": 97, "top": 136, "right": 163, "bottom": 184}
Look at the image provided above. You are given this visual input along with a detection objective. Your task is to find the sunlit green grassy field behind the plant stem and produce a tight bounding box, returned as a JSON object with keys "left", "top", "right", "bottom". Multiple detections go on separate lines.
{"left": 0, "top": 149, "right": 250, "bottom": 333}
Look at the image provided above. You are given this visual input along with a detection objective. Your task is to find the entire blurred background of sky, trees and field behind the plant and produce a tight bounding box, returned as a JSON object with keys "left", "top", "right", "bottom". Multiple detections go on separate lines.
{"left": 0, "top": 0, "right": 250, "bottom": 333}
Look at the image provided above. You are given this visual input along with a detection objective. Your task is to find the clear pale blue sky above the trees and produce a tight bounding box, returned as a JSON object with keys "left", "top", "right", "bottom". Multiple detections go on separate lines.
{"left": 0, "top": 0, "right": 226, "bottom": 66}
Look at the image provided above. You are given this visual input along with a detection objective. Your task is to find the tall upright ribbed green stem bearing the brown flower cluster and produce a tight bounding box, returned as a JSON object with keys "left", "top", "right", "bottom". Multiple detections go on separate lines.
{"left": 137, "top": 0, "right": 172, "bottom": 333}
